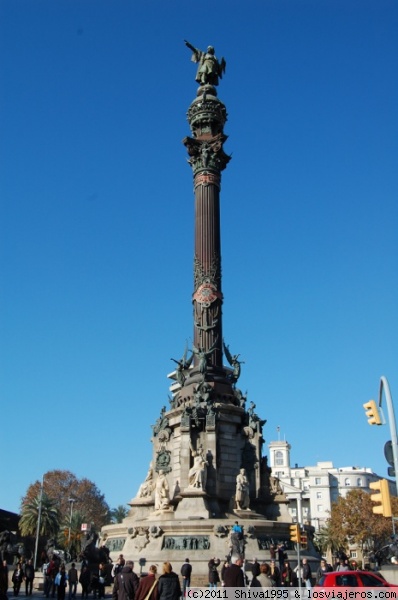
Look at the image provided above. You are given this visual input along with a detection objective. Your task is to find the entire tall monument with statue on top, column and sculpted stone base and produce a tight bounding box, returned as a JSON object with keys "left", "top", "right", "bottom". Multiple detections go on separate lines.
{"left": 100, "top": 42, "right": 310, "bottom": 575}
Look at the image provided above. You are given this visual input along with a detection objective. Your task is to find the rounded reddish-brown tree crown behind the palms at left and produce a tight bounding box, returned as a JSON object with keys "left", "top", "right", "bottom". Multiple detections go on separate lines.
{"left": 21, "top": 470, "right": 109, "bottom": 531}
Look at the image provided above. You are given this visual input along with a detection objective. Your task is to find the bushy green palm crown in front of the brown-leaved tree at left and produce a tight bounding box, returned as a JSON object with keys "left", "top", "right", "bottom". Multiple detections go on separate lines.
{"left": 19, "top": 493, "right": 59, "bottom": 536}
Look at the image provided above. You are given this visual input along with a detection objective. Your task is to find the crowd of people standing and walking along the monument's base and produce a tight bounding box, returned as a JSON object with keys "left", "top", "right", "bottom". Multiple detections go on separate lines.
{"left": 0, "top": 545, "right": 349, "bottom": 600}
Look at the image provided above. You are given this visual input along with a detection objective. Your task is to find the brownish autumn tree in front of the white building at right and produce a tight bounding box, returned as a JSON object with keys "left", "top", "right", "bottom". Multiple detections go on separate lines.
{"left": 327, "top": 489, "right": 398, "bottom": 552}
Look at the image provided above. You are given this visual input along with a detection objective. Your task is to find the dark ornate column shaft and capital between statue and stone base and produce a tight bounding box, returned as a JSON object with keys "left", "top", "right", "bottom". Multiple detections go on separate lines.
{"left": 183, "top": 84, "right": 230, "bottom": 374}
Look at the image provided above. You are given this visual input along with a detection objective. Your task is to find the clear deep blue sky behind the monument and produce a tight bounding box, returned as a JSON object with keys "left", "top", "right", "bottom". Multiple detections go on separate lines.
{"left": 0, "top": 0, "right": 398, "bottom": 511}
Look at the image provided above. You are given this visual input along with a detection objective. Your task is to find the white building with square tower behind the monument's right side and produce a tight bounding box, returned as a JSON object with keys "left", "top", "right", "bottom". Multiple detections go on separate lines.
{"left": 268, "top": 441, "right": 395, "bottom": 531}
